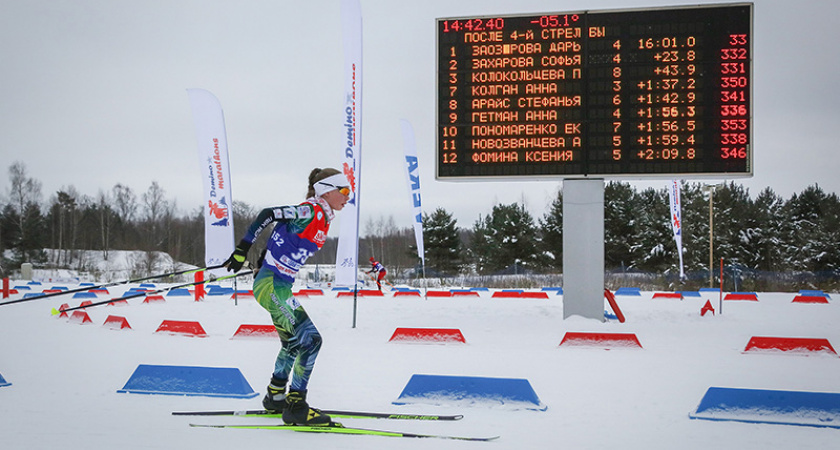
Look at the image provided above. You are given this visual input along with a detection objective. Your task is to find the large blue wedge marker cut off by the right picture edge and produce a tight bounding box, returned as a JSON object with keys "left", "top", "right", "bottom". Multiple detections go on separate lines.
{"left": 689, "top": 387, "right": 840, "bottom": 428}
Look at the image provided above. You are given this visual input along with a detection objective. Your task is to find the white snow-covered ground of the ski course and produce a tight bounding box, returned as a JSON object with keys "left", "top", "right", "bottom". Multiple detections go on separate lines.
{"left": 0, "top": 280, "right": 840, "bottom": 450}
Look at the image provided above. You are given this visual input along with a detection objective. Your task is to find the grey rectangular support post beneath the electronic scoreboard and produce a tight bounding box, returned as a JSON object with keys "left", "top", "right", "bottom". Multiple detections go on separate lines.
{"left": 563, "top": 179, "right": 604, "bottom": 322}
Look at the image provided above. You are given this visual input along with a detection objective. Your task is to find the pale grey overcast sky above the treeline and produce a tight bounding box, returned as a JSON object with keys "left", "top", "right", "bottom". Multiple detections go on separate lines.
{"left": 0, "top": 0, "right": 840, "bottom": 234}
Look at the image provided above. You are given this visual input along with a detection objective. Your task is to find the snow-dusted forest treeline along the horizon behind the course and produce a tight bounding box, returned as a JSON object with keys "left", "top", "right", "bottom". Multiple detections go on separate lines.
{"left": 0, "top": 162, "right": 840, "bottom": 290}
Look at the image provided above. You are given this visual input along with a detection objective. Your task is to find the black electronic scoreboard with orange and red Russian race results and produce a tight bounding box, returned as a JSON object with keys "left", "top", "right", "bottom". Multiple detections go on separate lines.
{"left": 436, "top": 3, "right": 753, "bottom": 179}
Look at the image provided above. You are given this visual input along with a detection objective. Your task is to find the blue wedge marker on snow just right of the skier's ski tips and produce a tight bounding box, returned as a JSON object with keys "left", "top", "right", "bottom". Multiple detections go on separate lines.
{"left": 392, "top": 374, "right": 548, "bottom": 411}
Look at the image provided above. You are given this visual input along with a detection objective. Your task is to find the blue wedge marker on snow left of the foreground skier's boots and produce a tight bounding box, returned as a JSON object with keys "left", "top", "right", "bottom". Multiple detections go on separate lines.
{"left": 117, "top": 364, "right": 259, "bottom": 398}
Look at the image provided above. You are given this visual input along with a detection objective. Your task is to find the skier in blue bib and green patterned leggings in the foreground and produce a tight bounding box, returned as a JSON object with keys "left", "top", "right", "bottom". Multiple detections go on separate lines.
{"left": 224, "top": 169, "right": 351, "bottom": 425}
